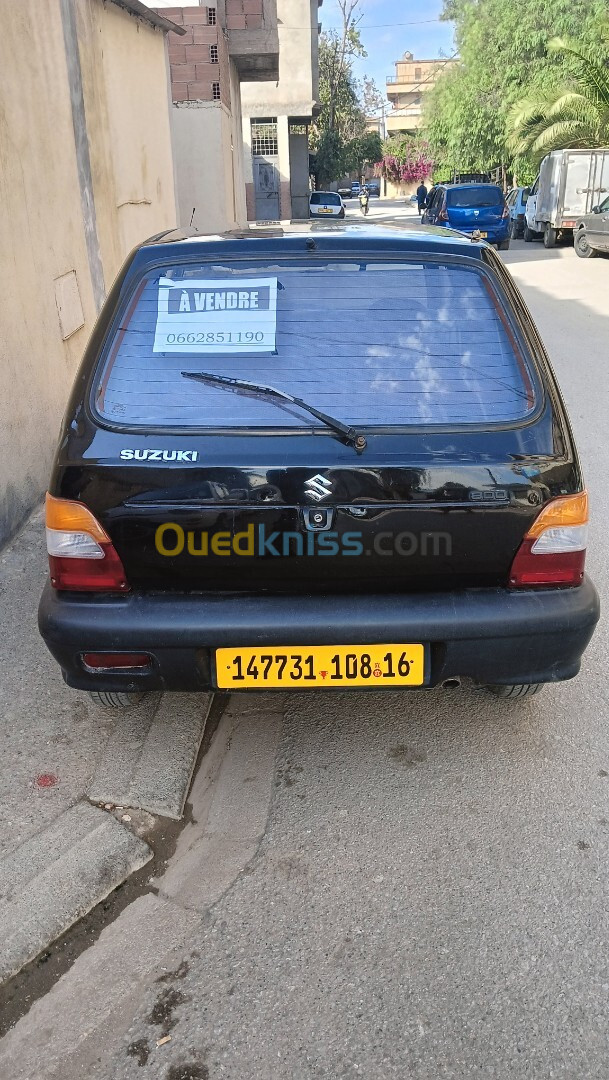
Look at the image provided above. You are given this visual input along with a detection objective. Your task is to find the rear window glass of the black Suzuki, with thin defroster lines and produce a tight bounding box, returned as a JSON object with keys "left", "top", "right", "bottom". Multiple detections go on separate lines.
{"left": 93, "top": 259, "right": 534, "bottom": 429}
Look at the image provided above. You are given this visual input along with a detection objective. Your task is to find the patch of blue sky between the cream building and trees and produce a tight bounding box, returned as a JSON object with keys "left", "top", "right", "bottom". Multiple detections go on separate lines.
{"left": 320, "top": 0, "right": 454, "bottom": 106}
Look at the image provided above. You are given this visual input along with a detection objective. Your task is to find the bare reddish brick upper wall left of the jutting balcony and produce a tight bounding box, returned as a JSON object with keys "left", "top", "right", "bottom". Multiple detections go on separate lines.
{"left": 157, "top": 7, "right": 229, "bottom": 108}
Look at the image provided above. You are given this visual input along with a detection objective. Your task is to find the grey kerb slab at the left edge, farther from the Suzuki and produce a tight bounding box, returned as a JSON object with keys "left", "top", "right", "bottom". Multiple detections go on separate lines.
{"left": 0, "top": 802, "right": 152, "bottom": 982}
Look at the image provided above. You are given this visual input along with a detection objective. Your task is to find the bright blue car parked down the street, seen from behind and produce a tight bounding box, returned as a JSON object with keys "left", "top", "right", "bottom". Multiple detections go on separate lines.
{"left": 421, "top": 184, "right": 510, "bottom": 251}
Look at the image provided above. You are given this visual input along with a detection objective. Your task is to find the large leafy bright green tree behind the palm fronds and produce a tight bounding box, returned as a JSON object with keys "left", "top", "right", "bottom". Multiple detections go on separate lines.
{"left": 423, "top": 0, "right": 607, "bottom": 178}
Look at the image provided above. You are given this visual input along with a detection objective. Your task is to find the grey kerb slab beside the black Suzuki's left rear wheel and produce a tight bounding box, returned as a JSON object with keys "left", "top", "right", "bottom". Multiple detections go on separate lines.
{"left": 89, "top": 693, "right": 213, "bottom": 820}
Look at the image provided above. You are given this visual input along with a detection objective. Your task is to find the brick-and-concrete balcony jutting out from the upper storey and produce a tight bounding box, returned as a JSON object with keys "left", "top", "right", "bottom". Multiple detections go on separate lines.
{"left": 218, "top": 0, "right": 279, "bottom": 82}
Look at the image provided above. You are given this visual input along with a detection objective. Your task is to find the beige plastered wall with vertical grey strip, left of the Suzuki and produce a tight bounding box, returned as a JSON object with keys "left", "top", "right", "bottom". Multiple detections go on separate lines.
{"left": 0, "top": 0, "right": 175, "bottom": 542}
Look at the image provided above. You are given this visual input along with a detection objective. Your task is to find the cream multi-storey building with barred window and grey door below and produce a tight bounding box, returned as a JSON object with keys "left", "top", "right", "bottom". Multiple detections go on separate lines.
{"left": 242, "top": 0, "right": 322, "bottom": 221}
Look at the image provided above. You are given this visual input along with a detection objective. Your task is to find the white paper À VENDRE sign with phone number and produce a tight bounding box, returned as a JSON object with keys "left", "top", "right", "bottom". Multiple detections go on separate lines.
{"left": 152, "top": 278, "right": 278, "bottom": 353}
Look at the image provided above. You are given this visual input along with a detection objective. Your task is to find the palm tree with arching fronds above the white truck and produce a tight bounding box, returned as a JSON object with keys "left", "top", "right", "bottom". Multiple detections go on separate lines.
{"left": 508, "top": 30, "right": 609, "bottom": 161}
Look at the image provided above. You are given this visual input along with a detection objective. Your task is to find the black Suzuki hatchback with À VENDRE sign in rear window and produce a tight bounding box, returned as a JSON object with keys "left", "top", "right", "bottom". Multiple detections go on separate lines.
{"left": 40, "top": 225, "right": 598, "bottom": 704}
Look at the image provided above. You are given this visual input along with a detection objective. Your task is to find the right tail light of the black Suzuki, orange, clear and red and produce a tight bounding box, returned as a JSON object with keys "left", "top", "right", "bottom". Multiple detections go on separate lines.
{"left": 510, "top": 491, "right": 587, "bottom": 588}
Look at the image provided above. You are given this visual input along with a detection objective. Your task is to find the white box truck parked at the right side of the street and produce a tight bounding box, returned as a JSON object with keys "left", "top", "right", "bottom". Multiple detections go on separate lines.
{"left": 525, "top": 148, "right": 609, "bottom": 247}
